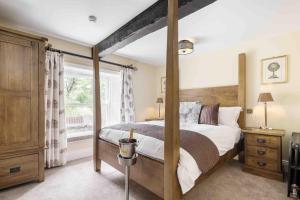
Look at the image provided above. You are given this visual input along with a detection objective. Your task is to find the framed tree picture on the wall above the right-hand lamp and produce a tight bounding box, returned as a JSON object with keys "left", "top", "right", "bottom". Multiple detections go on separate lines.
{"left": 261, "top": 56, "right": 288, "bottom": 84}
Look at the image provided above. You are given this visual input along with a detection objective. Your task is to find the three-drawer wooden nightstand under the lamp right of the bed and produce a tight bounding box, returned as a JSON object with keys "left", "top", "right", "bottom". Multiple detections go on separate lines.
{"left": 242, "top": 128, "right": 285, "bottom": 181}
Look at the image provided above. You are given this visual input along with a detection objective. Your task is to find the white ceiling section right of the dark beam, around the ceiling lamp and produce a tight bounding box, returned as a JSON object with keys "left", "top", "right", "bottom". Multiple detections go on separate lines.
{"left": 116, "top": 0, "right": 300, "bottom": 66}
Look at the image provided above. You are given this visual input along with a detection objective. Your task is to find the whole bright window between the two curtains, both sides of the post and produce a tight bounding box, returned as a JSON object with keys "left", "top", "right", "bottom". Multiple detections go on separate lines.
{"left": 64, "top": 64, "right": 121, "bottom": 141}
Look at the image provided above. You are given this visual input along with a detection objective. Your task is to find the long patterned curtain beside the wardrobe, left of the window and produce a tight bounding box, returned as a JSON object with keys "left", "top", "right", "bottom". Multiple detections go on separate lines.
{"left": 45, "top": 51, "right": 67, "bottom": 168}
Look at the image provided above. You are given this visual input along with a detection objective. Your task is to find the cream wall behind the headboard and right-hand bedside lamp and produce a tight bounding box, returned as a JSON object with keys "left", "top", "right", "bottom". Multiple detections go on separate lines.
{"left": 157, "top": 32, "right": 300, "bottom": 159}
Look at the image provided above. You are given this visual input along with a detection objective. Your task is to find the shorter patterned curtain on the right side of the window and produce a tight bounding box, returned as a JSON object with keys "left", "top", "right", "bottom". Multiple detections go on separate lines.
{"left": 121, "top": 68, "right": 135, "bottom": 123}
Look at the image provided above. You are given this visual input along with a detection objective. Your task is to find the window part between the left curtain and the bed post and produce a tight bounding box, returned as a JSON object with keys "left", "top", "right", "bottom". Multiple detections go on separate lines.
{"left": 64, "top": 65, "right": 93, "bottom": 138}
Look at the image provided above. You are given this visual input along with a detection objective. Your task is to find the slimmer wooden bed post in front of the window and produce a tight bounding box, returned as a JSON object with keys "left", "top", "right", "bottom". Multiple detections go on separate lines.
{"left": 92, "top": 47, "right": 101, "bottom": 172}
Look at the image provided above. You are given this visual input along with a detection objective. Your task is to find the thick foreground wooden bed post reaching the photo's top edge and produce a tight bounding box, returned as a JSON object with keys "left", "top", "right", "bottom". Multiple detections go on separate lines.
{"left": 164, "top": 0, "right": 181, "bottom": 200}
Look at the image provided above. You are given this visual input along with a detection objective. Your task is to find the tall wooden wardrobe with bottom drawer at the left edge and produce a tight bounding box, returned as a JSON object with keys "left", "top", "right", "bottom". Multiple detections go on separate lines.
{"left": 0, "top": 27, "right": 46, "bottom": 189}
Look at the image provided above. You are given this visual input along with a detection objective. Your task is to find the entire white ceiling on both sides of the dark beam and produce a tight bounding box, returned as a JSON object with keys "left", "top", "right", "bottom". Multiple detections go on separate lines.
{"left": 0, "top": 0, "right": 300, "bottom": 65}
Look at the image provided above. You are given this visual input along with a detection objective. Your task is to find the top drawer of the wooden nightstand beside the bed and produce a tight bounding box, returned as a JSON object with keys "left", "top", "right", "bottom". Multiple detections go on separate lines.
{"left": 246, "top": 134, "right": 281, "bottom": 148}
